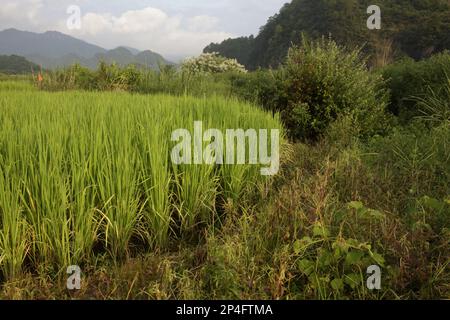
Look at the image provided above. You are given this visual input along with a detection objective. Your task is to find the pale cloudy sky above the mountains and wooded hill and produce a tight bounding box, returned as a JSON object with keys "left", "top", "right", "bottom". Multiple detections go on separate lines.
{"left": 0, "top": 0, "right": 289, "bottom": 58}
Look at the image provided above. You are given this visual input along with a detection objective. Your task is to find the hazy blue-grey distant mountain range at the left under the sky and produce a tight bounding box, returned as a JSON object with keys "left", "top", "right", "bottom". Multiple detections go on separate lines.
{"left": 0, "top": 29, "right": 172, "bottom": 69}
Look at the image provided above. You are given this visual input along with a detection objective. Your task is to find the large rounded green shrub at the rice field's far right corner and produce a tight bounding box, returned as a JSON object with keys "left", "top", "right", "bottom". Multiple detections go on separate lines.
{"left": 274, "top": 39, "right": 387, "bottom": 139}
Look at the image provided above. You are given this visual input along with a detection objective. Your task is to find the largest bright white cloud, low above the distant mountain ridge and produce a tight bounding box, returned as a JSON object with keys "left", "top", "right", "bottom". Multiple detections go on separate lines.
{"left": 64, "top": 7, "right": 236, "bottom": 56}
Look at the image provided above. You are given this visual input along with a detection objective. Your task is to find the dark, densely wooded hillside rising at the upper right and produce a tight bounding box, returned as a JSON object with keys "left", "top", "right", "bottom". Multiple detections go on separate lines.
{"left": 204, "top": 0, "right": 450, "bottom": 69}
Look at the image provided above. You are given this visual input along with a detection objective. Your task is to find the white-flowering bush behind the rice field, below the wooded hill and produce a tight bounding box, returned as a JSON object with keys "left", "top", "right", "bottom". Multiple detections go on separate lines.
{"left": 182, "top": 52, "right": 247, "bottom": 74}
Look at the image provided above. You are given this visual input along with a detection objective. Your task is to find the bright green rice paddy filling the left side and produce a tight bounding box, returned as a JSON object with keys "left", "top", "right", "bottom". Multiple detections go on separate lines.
{"left": 0, "top": 81, "right": 282, "bottom": 280}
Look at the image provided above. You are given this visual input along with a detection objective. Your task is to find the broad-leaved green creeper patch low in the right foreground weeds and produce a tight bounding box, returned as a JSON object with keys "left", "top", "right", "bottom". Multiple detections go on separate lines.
{"left": 293, "top": 201, "right": 387, "bottom": 299}
